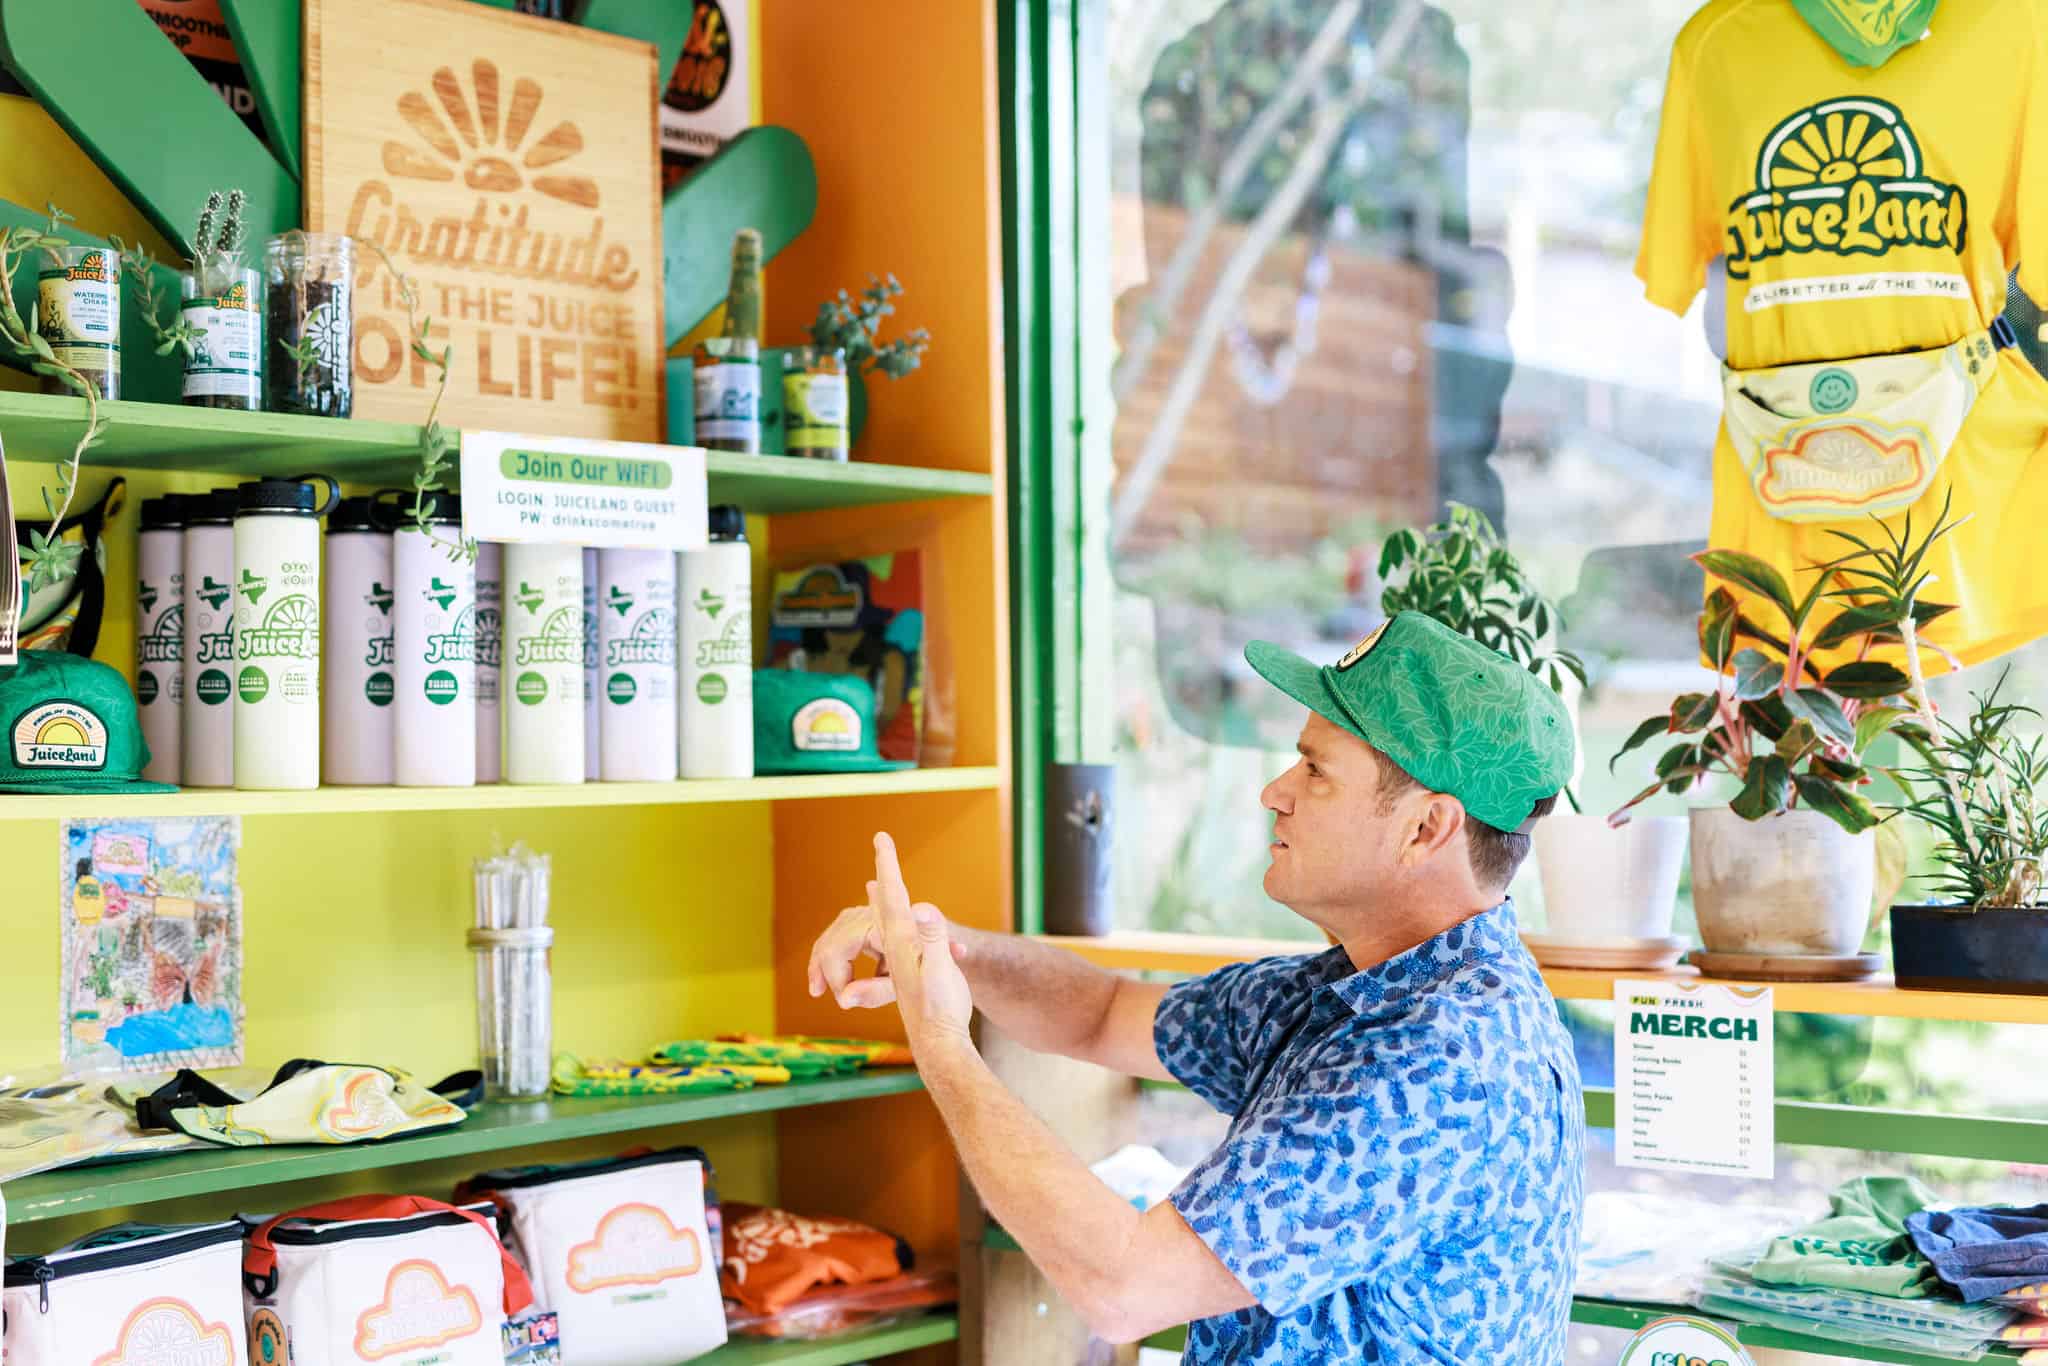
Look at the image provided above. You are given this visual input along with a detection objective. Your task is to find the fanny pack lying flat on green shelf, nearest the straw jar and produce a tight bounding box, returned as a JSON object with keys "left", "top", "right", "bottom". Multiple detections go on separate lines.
{"left": 135, "top": 1059, "right": 483, "bottom": 1147}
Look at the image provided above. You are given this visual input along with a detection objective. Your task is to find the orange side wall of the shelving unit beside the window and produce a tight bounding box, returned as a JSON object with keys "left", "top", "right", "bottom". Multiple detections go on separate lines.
{"left": 762, "top": 0, "right": 1012, "bottom": 1257}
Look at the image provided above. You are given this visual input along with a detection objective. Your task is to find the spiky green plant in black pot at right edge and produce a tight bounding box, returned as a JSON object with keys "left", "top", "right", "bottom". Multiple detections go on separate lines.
{"left": 1892, "top": 678, "right": 2048, "bottom": 995}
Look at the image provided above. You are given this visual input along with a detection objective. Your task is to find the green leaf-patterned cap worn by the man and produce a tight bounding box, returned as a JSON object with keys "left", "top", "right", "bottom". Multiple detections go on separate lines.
{"left": 1245, "top": 612, "right": 1573, "bottom": 829}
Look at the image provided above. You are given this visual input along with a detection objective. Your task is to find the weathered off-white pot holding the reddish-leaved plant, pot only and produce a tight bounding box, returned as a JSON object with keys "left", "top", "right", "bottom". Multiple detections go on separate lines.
{"left": 1692, "top": 807, "right": 1878, "bottom": 956}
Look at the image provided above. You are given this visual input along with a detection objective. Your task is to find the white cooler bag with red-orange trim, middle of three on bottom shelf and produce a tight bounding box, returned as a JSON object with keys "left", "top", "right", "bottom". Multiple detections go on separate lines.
{"left": 242, "top": 1196, "right": 532, "bottom": 1366}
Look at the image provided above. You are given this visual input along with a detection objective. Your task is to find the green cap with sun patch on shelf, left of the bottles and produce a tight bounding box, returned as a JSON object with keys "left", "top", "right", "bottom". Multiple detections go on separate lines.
{"left": 0, "top": 649, "right": 178, "bottom": 793}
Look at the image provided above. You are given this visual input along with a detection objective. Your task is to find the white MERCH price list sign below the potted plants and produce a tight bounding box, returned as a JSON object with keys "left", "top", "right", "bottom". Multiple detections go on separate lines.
{"left": 1614, "top": 981, "right": 1776, "bottom": 1180}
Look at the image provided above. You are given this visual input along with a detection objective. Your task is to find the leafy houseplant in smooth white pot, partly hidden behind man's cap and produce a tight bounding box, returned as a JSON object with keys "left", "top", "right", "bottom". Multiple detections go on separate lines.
{"left": 1378, "top": 504, "right": 1686, "bottom": 967}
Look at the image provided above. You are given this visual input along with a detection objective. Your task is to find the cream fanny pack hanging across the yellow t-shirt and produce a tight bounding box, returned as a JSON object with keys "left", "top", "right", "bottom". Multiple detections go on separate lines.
{"left": 1720, "top": 317, "right": 2013, "bottom": 522}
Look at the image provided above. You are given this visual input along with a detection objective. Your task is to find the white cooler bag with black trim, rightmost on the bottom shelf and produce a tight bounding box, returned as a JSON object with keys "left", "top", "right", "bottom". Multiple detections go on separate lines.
{"left": 457, "top": 1147, "right": 725, "bottom": 1366}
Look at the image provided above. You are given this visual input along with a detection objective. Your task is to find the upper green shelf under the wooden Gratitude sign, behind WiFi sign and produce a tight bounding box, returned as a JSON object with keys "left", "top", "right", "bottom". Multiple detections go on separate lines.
{"left": 0, "top": 391, "right": 995, "bottom": 514}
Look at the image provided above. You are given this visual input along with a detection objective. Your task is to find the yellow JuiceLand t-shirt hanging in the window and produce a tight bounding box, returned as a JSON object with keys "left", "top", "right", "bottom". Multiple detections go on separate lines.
{"left": 1636, "top": 0, "right": 2048, "bottom": 672}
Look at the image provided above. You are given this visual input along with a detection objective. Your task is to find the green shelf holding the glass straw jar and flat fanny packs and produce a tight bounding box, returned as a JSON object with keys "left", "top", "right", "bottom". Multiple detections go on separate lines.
{"left": 0, "top": 1067, "right": 924, "bottom": 1228}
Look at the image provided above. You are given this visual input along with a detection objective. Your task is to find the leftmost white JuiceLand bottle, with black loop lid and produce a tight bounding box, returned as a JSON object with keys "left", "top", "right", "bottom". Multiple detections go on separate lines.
{"left": 233, "top": 475, "right": 340, "bottom": 791}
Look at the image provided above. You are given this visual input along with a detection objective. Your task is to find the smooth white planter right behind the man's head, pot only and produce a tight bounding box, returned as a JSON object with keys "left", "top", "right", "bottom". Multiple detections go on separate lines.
{"left": 1534, "top": 809, "right": 1686, "bottom": 940}
